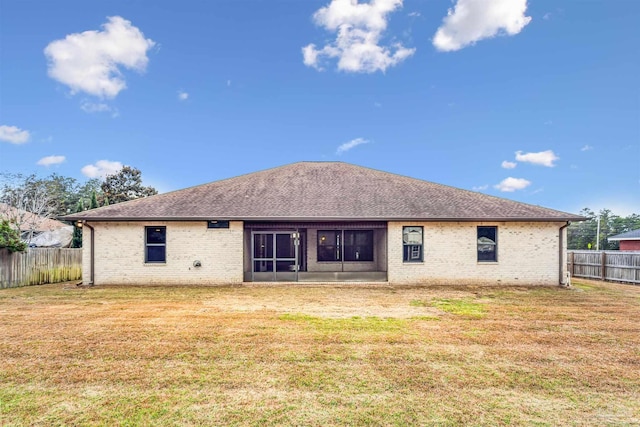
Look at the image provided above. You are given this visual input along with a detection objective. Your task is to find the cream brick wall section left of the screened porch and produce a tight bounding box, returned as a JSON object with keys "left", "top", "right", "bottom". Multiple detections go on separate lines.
{"left": 82, "top": 221, "right": 243, "bottom": 285}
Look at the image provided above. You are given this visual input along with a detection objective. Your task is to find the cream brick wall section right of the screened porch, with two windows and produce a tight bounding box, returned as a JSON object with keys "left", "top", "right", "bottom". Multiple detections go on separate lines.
{"left": 388, "top": 222, "right": 566, "bottom": 285}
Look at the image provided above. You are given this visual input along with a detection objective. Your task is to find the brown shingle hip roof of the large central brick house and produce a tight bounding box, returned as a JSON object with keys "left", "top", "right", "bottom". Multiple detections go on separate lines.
{"left": 63, "top": 162, "right": 585, "bottom": 221}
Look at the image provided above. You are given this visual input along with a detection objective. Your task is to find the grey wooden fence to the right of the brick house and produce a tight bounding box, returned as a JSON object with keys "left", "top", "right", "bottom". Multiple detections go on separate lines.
{"left": 567, "top": 251, "right": 640, "bottom": 285}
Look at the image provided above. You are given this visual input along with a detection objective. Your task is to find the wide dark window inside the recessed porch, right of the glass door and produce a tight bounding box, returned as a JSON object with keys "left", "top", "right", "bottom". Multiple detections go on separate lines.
{"left": 318, "top": 230, "right": 373, "bottom": 262}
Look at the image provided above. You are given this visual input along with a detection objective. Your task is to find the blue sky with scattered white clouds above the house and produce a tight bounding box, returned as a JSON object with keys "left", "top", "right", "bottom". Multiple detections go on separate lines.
{"left": 0, "top": 0, "right": 640, "bottom": 215}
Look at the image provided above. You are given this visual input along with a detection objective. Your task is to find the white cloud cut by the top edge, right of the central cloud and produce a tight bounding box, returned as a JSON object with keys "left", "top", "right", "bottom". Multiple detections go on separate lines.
{"left": 433, "top": 0, "right": 531, "bottom": 51}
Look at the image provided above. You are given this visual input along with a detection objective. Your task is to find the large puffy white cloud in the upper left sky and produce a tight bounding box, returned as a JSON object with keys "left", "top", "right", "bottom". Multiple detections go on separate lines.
{"left": 44, "top": 16, "right": 155, "bottom": 98}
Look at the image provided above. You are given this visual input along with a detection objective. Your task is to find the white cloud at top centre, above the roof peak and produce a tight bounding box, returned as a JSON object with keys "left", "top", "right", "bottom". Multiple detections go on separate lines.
{"left": 302, "top": 0, "right": 415, "bottom": 73}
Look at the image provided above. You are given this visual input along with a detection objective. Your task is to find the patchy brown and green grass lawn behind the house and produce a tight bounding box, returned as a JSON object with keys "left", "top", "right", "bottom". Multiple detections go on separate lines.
{"left": 0, "top": 281, "right": 640, "bottom": 426}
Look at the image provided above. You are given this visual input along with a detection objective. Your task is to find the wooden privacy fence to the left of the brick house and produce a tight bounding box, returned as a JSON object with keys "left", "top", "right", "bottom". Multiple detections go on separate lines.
{"left": 0, "top": 248, "right": 82, "bottom": 289}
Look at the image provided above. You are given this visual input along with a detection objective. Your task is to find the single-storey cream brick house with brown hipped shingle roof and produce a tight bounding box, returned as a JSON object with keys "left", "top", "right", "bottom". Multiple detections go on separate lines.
{"left": 64, "top": 162, "right": 584, "bottom": 285}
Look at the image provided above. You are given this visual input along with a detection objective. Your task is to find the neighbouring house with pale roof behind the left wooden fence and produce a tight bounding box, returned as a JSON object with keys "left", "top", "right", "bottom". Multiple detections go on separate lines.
{"left": 0, "top": 203, "right": 73, "bottom": 248}
